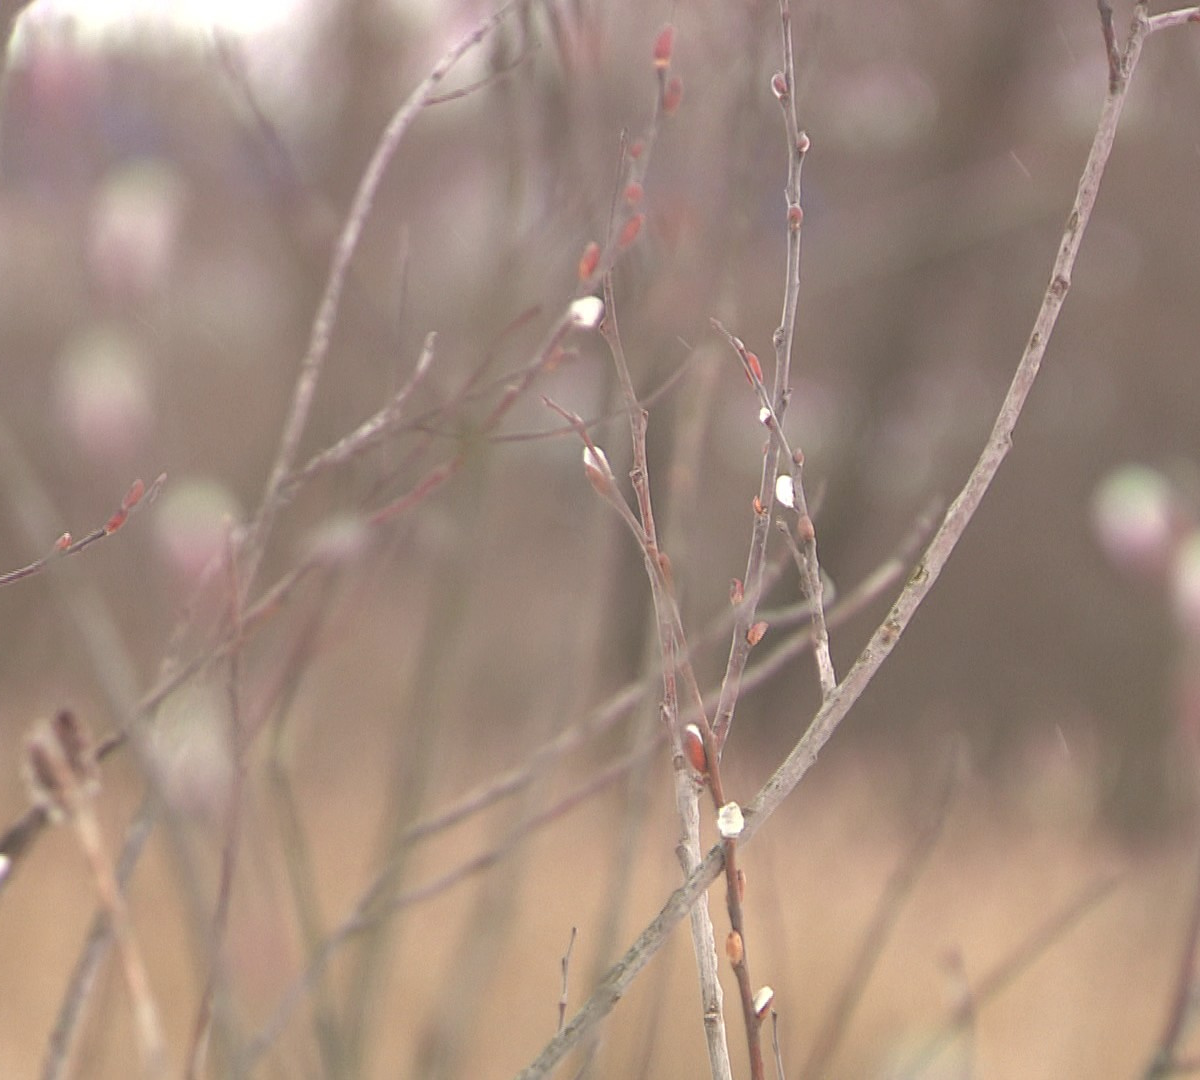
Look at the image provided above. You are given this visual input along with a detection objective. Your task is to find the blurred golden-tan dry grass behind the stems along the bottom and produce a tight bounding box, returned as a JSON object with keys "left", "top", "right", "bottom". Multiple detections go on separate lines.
{"left": 0, "top": 734, "right": 1194, "bottom": 1078}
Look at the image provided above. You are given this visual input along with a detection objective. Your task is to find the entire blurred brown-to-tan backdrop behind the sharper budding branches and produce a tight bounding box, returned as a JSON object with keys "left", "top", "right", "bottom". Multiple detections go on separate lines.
{"left": 0, "top": 0, "right": 1200, "bottom": 1078}
